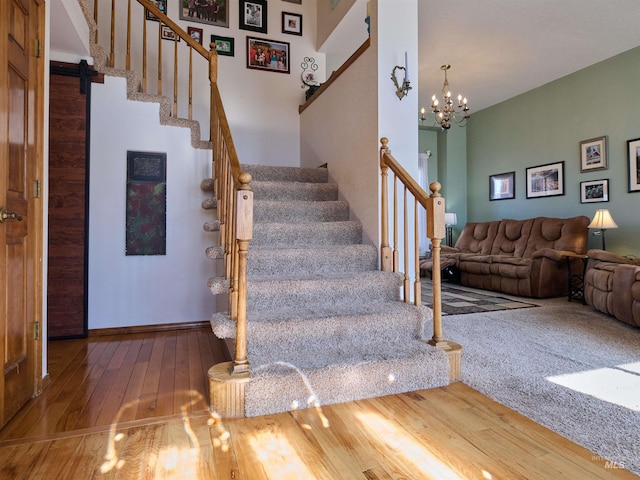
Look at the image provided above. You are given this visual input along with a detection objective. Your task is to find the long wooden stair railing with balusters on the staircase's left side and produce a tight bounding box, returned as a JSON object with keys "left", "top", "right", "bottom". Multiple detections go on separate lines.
{"left": 94, "top": 0, "right": 253, "bottom": 376}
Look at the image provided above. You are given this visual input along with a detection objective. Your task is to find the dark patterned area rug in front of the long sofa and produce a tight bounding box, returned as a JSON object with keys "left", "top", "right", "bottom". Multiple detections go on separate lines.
{"left": 422, "top": 280, "right": 536, "bottom": 315}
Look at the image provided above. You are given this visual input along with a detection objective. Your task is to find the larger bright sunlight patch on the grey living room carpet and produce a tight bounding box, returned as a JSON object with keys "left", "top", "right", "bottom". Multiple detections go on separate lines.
{"left": 547, "top": 362, "right": 640, "bottom": 412}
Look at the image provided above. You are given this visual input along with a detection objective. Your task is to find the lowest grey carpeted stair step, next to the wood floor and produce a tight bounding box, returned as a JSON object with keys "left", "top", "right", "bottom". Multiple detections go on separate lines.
{"left": 245, "top": 340, "right": 449, "bottom": 417}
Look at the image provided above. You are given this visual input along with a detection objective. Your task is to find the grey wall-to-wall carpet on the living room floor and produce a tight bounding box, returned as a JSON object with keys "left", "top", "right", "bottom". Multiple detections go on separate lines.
{"left": 443, "top": 298, "right": 640, "bottom": 474}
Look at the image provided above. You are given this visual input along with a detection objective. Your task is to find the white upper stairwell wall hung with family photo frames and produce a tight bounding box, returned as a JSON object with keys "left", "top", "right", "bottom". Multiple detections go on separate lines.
{"left": 92, "top": 0, "right": 325, "bottom": 166}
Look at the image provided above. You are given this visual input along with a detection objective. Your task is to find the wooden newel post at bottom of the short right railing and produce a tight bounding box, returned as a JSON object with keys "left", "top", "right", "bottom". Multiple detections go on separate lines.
{"left": 426, "top": 182, "right": 447, "bottom": 348}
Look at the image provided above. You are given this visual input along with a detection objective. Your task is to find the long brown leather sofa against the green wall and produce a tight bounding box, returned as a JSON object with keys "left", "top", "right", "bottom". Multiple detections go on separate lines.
{"left": 420, "top": 216, "right": 589, "bottom": 298}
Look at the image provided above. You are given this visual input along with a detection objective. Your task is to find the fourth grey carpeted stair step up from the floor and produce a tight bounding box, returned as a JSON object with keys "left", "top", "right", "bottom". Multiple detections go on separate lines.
{"left": 247, "top": 245, "right": 378, "bottom": 279}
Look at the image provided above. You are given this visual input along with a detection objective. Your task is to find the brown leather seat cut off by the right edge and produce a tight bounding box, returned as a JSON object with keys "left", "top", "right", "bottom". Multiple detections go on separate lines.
{"left": 584, "top": 250, "right": 640, "bottom": 327}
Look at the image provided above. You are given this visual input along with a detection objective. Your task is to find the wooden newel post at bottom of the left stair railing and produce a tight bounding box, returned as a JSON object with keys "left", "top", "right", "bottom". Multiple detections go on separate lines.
{"left": 230, "top": 172, "right": 253, "bottom": 375}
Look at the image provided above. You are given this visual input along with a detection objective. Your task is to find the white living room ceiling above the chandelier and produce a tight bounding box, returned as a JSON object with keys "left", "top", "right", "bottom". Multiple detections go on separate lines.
{"left": 418, "top": 0, "right": 640, "bottom": 114}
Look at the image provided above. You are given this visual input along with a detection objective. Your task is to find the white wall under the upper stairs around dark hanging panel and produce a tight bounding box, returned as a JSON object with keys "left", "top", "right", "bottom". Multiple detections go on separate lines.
{"left": 88, "top": 77, "right": 215, "bottom": 329}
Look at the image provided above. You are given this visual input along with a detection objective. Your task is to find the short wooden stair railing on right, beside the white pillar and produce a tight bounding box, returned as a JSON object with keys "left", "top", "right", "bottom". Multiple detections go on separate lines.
{"left": 380, "top": 137, "right": 449, "bottom": 350}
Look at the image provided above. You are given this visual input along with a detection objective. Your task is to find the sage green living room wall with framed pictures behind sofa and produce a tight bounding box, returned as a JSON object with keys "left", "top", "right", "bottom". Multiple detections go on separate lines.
{"left": 464, "top": 47, "right": 640, "bottom": 256}
